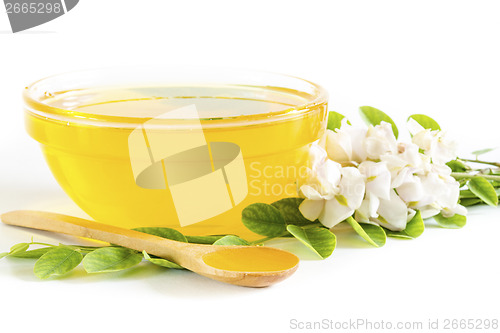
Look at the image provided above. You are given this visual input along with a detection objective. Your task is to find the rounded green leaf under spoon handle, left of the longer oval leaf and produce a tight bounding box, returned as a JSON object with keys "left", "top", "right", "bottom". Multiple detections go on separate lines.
{"left": 33, "top": 246, "right": 83, "bottom": 279}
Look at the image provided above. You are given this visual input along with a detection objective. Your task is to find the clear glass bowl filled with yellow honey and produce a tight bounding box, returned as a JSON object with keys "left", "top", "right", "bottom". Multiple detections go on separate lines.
{"left": 26, "top": 79, "right": 327, "bottom": 239}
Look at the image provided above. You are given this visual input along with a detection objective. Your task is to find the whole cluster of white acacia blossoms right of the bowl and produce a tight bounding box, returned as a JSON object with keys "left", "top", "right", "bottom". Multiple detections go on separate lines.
{"left": 299, "top": 118, "right": 466, "bottom": 231}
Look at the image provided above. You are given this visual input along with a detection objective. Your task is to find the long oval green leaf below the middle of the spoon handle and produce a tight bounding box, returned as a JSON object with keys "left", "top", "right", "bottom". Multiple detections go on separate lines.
{"left": 83, "top": 247, "right": 142, "bottom": 273}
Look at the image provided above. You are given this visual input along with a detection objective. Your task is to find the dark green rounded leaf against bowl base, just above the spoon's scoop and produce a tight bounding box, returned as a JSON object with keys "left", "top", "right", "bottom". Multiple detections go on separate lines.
{"left": 241, "top": 203, "right": 286, "bottom": 237}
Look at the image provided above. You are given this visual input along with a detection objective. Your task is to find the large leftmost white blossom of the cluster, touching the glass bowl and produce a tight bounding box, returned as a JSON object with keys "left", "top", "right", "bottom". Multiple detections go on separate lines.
{"left": 299, "top": 146, "right": 365, "bottom": 228}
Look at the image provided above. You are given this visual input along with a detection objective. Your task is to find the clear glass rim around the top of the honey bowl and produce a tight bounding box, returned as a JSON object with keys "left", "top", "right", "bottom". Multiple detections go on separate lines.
{"left": 23, "top": 66, "right": 329, "bottom": 128}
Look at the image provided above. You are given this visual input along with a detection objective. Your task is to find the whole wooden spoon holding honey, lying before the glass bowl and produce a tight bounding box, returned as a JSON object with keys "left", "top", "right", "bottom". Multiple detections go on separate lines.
{"left": 1, "top": 210, "right": 299, "bottom": 287}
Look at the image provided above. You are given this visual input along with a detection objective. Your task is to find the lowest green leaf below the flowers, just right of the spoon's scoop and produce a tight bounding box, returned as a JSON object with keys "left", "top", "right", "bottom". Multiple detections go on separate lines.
{"left": 287, "top": 224, "right": 337, "bottom": 259}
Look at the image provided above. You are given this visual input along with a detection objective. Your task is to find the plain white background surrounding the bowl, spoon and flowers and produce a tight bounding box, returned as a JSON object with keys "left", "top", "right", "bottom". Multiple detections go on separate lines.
{"left": 0, "top": 0, "right": 500, "bottom": 332}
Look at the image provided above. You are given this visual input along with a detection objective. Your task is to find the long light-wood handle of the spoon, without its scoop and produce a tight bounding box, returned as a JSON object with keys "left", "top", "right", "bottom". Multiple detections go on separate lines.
{"left": 1, "top": 210, "right": 193, "bottom": 260}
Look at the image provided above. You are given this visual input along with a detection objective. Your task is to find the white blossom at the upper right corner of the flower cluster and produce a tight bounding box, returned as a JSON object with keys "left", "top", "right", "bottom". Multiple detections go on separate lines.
{"left": 407, "top": 118, "right": 457, "bottom": 164}
